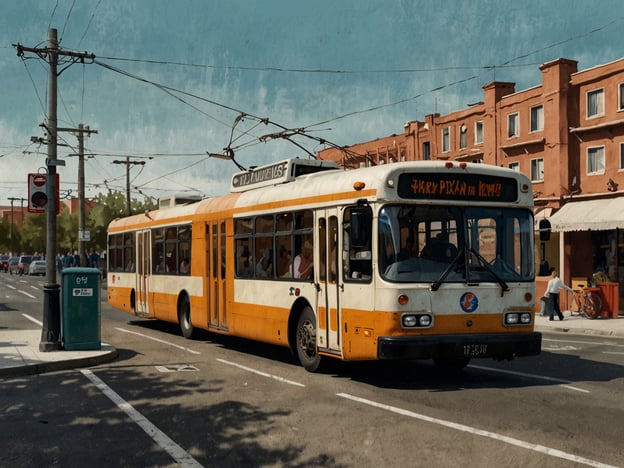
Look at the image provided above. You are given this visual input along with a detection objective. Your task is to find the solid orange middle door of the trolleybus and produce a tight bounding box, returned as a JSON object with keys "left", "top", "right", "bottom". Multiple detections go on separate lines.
{"left": 206, "top": 222, "right": 228, "bottom": 330}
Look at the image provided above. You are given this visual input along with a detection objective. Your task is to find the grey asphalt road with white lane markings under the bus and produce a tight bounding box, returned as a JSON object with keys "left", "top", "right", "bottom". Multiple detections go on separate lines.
{"left": 0, "top": 274, "right": 624, "bottom": 467}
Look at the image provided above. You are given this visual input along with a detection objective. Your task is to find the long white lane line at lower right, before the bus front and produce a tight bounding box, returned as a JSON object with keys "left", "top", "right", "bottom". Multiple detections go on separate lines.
{"left": 336, "top": 393, "right": 617, "bottom": 468}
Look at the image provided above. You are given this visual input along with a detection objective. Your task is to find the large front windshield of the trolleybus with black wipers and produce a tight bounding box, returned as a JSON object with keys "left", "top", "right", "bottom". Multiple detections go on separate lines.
{"left": 378, "top": 205, "right": 534, "bottom": 290}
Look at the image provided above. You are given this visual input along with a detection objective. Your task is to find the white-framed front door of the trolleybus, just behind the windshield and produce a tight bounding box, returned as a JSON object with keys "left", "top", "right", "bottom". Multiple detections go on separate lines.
{"left": 317, "top": 209, "right": 342, "bottom": 355}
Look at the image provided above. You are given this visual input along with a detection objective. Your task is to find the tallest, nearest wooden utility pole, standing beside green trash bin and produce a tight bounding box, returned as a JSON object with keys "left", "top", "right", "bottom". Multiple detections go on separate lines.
{"left": 13, "top": 29, "right": 95, "bottom": 352}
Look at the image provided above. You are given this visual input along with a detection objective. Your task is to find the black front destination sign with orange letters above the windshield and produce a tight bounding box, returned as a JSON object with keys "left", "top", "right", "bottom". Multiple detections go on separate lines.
{"left": 398, "top": 172, "right": 518, "bottom": 202}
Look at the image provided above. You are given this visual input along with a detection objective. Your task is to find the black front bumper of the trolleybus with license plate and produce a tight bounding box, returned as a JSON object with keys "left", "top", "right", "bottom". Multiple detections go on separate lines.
{"left": 377, "top": 332, "right": 542, "bottom": 360}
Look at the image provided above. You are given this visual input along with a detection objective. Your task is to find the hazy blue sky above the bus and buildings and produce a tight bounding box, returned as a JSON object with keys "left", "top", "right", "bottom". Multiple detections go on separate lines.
{"left": 0, "top": 0, "right": 624, "bottom": 205}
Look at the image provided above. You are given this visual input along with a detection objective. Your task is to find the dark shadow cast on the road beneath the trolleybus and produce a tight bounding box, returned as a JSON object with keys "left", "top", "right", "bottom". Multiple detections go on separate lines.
{"left": 119, "top": 320, "right": 624, "bottom": 392}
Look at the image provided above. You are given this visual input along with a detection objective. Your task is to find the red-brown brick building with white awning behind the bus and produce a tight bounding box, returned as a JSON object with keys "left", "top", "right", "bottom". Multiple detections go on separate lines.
{"left": 318, "top": 58, "right": 624, "bottom": 314}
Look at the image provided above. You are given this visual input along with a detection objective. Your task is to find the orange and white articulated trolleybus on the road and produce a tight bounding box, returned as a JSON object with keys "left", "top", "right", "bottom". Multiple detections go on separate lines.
{"left": 107, "top": 159, "right": 541, "bottom": 371}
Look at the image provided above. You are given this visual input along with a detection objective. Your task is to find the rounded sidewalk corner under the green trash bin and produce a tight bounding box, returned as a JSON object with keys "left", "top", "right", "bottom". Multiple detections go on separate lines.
{"left": 0, "top": 329, "right": 118, "bottom": 378}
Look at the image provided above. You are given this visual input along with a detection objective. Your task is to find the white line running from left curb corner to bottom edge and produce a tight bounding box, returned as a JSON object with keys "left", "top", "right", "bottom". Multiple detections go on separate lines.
{"left": 80, "top": 369, "right": 203, "bottom": 468}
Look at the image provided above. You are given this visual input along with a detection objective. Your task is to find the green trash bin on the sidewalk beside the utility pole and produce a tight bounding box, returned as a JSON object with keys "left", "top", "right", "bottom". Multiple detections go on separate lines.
{"left": 61, "top": 268, "right": 102, "bottom": 351}
